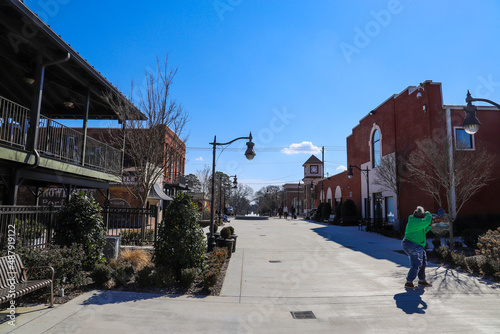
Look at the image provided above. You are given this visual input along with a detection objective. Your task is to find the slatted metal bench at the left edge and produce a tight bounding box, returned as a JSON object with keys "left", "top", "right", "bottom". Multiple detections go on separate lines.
{"left": 0, "top": 254, "right": 54, "bottom": 307}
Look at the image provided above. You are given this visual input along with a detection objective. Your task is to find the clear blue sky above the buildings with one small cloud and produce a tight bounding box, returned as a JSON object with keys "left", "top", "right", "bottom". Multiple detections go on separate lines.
{"left": 25, "top": 0, "right": 500, "bottom": 189}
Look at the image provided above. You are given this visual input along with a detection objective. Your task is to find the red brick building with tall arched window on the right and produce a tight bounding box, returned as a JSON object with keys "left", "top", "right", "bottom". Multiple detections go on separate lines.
{"left": 315, "top": 81, "right": 500, "bottom": 226}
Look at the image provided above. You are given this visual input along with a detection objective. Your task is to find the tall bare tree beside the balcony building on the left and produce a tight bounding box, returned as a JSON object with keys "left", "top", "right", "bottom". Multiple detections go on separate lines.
{"left": 103, "top": 55, "right": 188, "bottom": 206}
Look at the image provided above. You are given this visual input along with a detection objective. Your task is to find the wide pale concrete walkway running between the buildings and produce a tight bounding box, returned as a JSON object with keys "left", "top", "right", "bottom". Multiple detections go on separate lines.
{"left": 0, "top": 218, "right": 500, "bottom": 334}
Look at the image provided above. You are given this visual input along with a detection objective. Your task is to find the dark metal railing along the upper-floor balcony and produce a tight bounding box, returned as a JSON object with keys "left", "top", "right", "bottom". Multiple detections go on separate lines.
{"left": 0, "top": 96, "right": 122, "bottom": 173}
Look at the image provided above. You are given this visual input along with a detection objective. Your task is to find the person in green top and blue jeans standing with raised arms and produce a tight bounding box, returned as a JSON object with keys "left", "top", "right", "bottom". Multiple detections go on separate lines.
{"left": 401, "top": 206, "right": 432, "bottom": 289}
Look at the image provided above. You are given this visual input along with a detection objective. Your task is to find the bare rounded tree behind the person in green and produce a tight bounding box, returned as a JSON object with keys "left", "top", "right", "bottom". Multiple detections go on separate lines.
{"left": 406, "top": 136, "right": 494, "bottom": 250}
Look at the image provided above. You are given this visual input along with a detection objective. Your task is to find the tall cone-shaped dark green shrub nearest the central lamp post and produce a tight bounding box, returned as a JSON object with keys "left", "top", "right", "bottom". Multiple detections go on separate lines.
{"left": 154, "top": 193, "right": 206, "bottom": 279}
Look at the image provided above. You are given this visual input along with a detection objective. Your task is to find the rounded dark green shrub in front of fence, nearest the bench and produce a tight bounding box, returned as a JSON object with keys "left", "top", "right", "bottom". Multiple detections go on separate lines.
{"left": 54, "top": 192, "right": 106, "bottom": 270}
